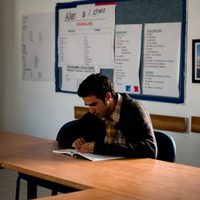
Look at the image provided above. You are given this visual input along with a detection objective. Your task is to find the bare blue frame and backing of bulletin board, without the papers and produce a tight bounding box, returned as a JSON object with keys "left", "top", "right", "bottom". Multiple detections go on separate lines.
{"left": 55, "top": 0, "right": 186, "bottom": 103}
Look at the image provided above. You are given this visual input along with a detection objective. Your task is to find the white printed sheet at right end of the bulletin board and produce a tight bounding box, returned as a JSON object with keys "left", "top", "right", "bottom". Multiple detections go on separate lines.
{"left": 143, "top": 23, "right": 181, "bottom": 97}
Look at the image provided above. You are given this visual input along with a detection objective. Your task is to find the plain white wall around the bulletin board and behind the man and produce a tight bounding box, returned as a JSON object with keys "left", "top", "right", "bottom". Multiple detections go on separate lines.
{"left": 0, "top": 0, "right": 200, "bottom": 166}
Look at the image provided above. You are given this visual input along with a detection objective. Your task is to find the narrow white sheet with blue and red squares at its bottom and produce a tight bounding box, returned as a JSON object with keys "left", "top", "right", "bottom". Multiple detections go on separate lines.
{"left": 114, "top": 24, "right": 142, "bottom": 94}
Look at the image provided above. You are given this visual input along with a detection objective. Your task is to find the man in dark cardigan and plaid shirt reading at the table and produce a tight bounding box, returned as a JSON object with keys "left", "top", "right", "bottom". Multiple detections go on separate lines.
{"left": 57, "top": 74, "right": 157, "bottom": 158}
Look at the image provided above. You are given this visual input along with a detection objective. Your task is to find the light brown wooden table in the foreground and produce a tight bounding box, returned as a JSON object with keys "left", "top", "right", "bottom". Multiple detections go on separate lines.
{"left": 0, "top": 132, "right": 200, "bottom": 200}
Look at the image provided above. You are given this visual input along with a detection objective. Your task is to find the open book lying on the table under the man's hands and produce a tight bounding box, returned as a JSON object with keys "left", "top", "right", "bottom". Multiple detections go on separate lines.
{"left": 53, "top": 149, "right": 123, "bottom": 161}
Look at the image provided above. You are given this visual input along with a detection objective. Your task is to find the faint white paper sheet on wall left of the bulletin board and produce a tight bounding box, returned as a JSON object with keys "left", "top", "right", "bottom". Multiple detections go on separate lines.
{"left": 22, "top": 12, "right": 55, "bottom": 81}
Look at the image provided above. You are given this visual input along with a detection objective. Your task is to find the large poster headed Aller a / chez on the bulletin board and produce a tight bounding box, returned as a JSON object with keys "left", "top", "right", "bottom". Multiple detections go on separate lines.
{"left": 58, "top": 3, "right": 115, "bottom": 92}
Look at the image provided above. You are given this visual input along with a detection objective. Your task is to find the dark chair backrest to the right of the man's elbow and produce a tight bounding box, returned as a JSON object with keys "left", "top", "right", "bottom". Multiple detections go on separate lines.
{"left": 154, "top": 131, "right": 176, "bottom": 162}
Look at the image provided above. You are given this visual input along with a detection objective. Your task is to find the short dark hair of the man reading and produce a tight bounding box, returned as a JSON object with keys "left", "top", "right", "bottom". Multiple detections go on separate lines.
{"left": 77, "top": 74, "right": 116, "bottom": 101}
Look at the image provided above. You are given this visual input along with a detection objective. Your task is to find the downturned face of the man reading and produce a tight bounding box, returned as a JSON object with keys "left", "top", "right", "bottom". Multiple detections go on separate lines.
{"left": 83, "top": 96, "right": 109, "bottom": 118}
